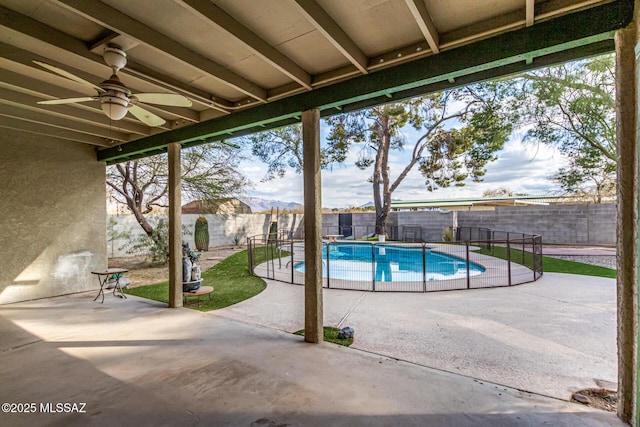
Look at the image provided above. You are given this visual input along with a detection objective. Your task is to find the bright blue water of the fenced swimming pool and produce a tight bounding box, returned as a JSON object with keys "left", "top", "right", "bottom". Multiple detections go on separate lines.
{"left": 295, "top": 243, "right": 485, "bottom": 282}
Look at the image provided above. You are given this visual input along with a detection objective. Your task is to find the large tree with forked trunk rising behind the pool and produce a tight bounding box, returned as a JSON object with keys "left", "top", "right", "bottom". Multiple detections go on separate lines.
{"left": 248, "top": 83, "right": 511, "bottom": 233}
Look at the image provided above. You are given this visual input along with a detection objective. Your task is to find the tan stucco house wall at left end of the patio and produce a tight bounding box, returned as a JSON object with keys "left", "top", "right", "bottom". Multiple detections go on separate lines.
{"left": 0, "top": 129, "right": 107, "bottom": 304}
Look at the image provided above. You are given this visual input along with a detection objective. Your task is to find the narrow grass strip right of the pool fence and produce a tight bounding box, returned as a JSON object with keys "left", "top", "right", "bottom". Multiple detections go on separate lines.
{"left": 476, "top": 246, "right": 616, "bottom": 279}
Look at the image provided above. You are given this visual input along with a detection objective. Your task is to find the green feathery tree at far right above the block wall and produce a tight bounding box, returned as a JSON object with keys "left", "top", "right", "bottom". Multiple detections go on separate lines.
{"left": 510, "top": 55, "right": 616, "bottom": 203}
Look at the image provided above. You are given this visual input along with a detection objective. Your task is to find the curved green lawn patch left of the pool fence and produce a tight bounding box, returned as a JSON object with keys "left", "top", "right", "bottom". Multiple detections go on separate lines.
{"left": 124, "top": 250, "right": 266, "bottom": 311}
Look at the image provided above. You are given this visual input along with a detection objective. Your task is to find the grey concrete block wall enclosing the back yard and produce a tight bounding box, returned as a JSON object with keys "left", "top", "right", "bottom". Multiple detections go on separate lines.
{"left": 108, "top": 205, "right": 616, "bottom": 256}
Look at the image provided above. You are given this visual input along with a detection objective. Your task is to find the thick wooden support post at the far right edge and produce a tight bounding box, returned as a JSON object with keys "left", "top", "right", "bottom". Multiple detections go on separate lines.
{"left": 615, "top": 0, "right": 640, "bottom": 425}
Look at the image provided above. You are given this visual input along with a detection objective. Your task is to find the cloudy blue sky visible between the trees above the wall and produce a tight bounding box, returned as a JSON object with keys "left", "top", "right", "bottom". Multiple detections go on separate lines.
{"left": 241, "top": 126, "right": 566, "bottom": 208}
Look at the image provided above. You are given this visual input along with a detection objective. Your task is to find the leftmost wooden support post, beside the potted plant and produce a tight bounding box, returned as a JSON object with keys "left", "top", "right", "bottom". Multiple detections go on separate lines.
{"left": 167, "top": 142, "right": 182, "bottom": 308}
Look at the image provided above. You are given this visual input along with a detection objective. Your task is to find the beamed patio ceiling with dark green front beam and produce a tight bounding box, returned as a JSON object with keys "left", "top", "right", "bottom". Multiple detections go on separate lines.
{"left": 0, "top": 0, "right": 633, "bottom": 162}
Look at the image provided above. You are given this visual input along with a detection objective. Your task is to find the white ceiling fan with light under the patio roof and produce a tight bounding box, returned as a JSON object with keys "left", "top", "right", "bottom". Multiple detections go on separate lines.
{"left": 33, "top": 44, "right": 191, "bottom": 126}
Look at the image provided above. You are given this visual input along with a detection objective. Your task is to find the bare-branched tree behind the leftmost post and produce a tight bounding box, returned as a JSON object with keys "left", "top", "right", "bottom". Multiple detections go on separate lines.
{"left": 107, "top": 144, "right": 246, "bottom": 252}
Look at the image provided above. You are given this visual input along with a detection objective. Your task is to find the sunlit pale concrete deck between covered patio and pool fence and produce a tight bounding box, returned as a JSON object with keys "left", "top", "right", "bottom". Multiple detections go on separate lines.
{"left": 217, "top": 273, "right": 617, "bottom": 400}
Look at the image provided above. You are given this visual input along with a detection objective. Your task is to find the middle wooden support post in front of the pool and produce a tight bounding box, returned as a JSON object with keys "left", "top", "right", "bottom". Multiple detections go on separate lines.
{"left": 302, "top": 110, "right": 324, "bottom": 343}
